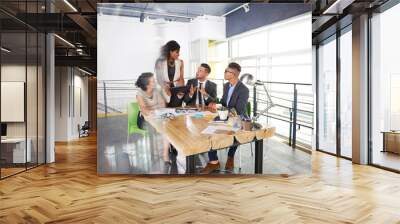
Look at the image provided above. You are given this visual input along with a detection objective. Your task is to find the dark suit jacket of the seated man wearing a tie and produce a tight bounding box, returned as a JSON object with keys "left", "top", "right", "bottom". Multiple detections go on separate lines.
{"left": 183, "top": 79, "right": 217, "bottom": 106}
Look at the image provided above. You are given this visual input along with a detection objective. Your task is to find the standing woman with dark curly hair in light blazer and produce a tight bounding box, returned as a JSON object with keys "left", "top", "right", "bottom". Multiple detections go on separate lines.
{"left": 155, "top": 40, "right": 185, "bottom": 107}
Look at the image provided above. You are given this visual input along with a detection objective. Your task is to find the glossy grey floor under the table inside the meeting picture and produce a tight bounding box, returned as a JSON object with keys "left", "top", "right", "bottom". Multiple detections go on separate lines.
{"left": 97, "top": 116, "right": 311, "bottom": 175}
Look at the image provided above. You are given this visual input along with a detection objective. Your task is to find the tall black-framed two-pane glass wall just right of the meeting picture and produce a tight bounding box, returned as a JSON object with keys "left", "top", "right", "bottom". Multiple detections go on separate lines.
{"left": 317, "top": 25, "right": 352, "bottom": 159}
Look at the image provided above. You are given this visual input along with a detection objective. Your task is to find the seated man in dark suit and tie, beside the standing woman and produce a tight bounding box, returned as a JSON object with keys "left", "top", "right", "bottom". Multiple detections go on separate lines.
{"left": 183, "top": 63, "right": 217, "bottom": 106}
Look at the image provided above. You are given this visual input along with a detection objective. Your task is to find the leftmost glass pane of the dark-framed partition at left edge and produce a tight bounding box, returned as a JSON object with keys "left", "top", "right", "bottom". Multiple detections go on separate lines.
{"left": 0, "top": 29, "right": 30, "bottom": 178}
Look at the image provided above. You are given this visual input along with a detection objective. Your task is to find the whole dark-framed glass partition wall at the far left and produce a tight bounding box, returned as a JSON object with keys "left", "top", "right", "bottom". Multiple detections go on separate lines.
{"left": 0, "top": 1, "right": 46, "bottom": 179}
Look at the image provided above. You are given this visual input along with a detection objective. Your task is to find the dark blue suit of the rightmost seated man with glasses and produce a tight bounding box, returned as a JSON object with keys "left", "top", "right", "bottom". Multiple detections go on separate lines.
{"left": 208, "top": 81, "right": 249, "bottom": 161}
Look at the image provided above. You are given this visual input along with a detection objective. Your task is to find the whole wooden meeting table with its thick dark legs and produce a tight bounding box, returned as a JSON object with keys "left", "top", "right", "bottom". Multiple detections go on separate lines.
{"left": 145, "top": 107, "right": 275, "bottom": 174}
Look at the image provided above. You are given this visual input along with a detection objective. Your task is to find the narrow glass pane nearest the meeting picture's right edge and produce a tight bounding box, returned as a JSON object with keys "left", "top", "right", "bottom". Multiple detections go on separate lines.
{"left": 318, "top": 40, "right": 336, "bottom": 154}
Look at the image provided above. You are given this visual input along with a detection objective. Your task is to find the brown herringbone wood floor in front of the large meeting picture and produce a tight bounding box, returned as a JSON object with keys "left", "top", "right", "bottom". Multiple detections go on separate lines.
{"left": 0, "top": 134, "right": 400, "bottom": 224}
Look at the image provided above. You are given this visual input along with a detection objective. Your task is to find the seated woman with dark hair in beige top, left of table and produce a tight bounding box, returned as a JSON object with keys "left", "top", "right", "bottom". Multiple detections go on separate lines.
{"left": 135, "top": 72, "right": 171, "bottom": 163}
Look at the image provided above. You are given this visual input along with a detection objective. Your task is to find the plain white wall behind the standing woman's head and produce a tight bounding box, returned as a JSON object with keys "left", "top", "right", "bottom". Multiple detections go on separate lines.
{"left": 97, "top": 15, "right": 225, "bottom": 81}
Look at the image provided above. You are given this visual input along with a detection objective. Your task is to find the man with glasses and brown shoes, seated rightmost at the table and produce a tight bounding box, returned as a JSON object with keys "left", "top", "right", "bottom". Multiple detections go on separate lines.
{"left": 201, "top": 62, "right": 249, "bottom": 174}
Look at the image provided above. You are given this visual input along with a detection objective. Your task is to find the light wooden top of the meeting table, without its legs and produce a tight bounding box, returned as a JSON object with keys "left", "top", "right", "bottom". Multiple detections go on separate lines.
{"left": 145, "top": 109, "right": 275, "bottom": 156}
